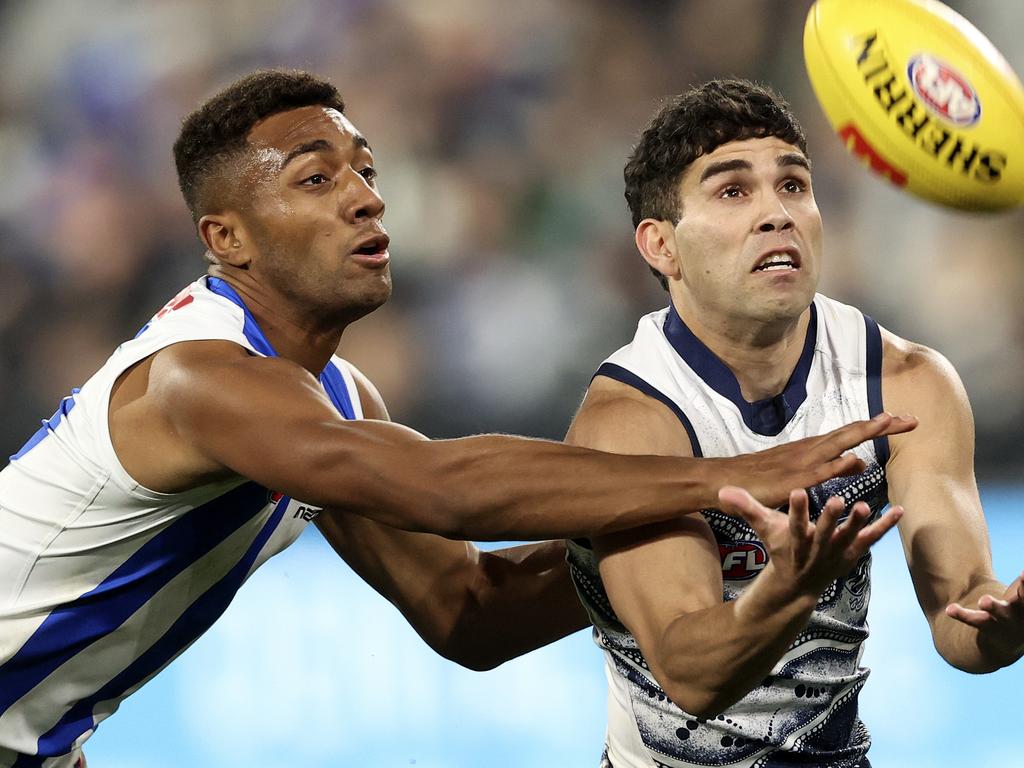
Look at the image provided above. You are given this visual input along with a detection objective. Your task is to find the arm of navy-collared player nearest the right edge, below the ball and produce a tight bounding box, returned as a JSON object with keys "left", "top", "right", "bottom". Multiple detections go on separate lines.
{"left": 883, "top": 334, "right": 1024, "bottom": 673}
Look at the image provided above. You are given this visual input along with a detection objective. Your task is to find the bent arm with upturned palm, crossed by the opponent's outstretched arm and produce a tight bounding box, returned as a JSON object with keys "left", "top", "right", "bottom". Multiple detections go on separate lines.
{"left": 569, "top": 381, "right": 898, "bottom": 717}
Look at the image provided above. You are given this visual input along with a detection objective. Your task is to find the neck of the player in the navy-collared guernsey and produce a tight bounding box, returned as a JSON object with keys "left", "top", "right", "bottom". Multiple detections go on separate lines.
{"left": 673, "top": 298, "right": 811, "bottom": 402}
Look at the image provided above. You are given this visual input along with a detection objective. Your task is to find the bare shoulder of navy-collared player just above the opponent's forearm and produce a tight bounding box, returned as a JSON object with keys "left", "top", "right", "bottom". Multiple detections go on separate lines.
{"left": 565, "top": 376, "right": 693, "bottom": 456}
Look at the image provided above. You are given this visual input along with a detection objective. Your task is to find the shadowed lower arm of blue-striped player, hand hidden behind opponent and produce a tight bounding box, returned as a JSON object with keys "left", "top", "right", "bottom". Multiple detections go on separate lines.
{"left": 316, "top": 371, "right": 588, "bottom": 670}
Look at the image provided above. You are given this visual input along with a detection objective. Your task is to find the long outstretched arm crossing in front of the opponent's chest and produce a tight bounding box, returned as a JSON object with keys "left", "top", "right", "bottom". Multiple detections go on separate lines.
{"left": 111, "top": 341, "right": 902, "bottom": 540}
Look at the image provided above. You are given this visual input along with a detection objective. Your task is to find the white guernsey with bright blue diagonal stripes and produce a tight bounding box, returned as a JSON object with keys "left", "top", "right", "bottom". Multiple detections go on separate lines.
{"left": 0, "top": 278, "right": 362, "bottom": 768}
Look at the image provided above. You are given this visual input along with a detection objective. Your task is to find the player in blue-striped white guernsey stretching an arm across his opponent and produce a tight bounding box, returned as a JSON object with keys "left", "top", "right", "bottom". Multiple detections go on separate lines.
{"left": 0, "top": 72, "right": 913, "bottom": 768}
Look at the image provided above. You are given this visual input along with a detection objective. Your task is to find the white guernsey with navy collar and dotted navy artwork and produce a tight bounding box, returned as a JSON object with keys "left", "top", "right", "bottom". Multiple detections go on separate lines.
{"left": 568, "top": 295, "right": 889, "bottom": 768}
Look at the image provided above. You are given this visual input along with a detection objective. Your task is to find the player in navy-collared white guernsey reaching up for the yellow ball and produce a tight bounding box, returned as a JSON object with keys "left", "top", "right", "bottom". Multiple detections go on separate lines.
{"left": 567, "top": 80, "right": 1024, "bottom": 768}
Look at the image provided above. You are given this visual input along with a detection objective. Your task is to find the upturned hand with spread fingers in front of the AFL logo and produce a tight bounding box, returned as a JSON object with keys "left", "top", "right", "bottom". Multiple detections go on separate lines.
{"left": 718, "top": 486, "right": 903, "bottom": 596}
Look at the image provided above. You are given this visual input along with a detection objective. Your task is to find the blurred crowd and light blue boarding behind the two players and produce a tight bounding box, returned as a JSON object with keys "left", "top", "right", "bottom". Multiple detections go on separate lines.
{"left": 0, "top": 0, "right": 1024, "bottom": 768}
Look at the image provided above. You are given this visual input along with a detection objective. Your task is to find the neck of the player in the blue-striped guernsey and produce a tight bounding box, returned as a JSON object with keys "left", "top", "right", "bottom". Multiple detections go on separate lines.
{"left": 209, "top": 266, "right": 350, "bottom": 376}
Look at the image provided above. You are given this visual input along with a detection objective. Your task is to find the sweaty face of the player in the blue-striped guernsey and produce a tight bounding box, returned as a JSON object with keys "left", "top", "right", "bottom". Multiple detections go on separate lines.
{"left": 237, "top": 106, "right": 391, "bottom": 319}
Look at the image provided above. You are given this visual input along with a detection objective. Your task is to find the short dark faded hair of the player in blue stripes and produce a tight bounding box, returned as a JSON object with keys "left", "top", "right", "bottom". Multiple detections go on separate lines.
{"left": 168, "top": 70, "right": 345, "bottom": 221}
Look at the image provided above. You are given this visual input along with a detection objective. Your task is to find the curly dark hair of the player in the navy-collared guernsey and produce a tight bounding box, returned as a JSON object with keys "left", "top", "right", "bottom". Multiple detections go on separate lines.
{"left": 623, "top": 79, "right": 807, "bottom": 290}
